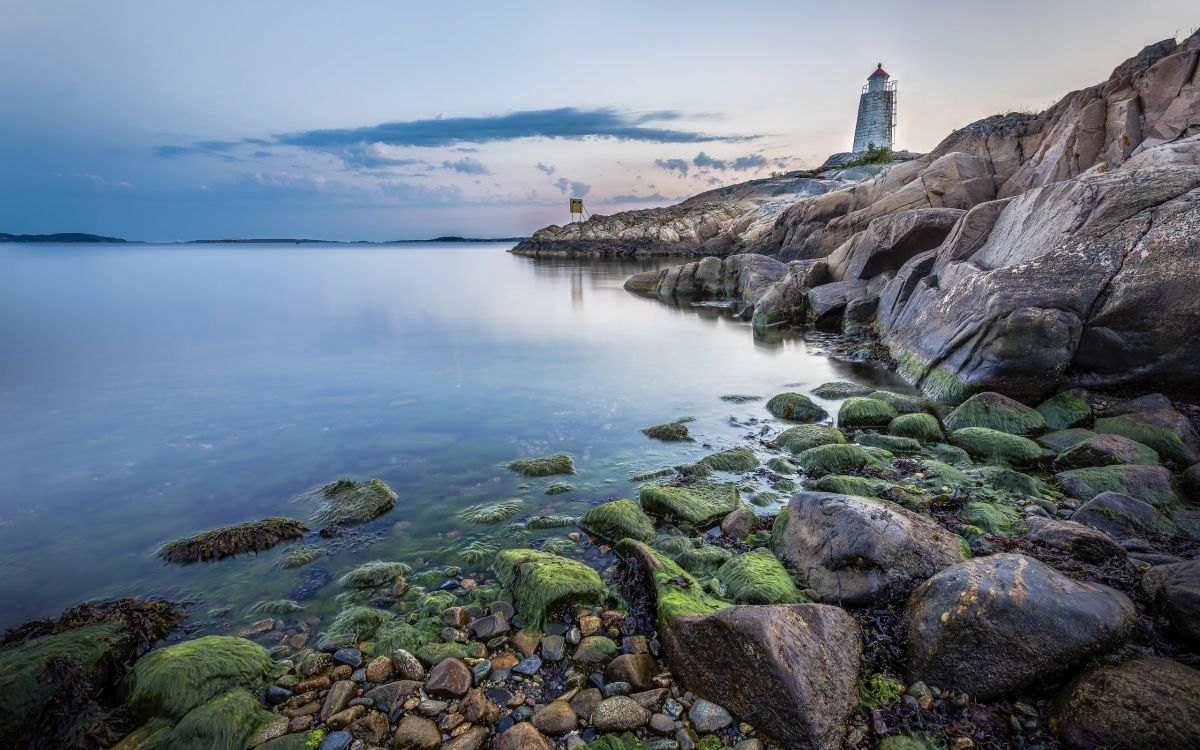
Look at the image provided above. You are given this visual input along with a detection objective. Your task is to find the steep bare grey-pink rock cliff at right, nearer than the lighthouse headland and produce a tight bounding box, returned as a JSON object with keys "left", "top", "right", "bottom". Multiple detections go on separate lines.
{"left": 630, "top": 35, "right": 1200, "bottom": 400}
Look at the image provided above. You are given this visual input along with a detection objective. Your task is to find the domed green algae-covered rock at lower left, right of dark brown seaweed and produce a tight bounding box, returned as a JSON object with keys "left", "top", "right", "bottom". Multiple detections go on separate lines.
{"left": 126, "top": 636, "right": 271, "bottom": 722}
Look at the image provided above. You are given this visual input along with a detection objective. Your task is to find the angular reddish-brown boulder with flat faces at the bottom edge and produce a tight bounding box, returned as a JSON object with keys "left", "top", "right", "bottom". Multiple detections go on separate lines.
{"left": 664, "top": 604, "right": 862, "bottom": 749}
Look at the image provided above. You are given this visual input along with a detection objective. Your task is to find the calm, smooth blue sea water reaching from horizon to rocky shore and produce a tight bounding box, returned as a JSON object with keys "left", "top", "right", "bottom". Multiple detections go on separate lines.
{"left": 0, "top": 244, "right": 898, "bottom": 628}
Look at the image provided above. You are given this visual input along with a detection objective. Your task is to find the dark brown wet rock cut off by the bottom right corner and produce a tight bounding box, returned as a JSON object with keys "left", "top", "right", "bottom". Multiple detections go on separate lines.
{"left": 1050, "top": 655, "right": 1200, "bottom": 750}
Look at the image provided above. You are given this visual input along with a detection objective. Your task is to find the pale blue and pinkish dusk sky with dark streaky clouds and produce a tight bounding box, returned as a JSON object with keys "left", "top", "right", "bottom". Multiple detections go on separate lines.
{"left": 0, "top": 0, "right": 1200, "bottom": 241}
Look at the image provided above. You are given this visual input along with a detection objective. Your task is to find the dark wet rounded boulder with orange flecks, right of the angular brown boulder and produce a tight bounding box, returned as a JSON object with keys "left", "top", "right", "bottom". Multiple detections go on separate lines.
{"left": 906, "top": 553, "right": 1136, "bottom": 701}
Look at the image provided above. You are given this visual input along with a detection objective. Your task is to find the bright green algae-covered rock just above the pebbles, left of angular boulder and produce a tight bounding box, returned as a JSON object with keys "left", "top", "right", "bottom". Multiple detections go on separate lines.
{"left": 494, "top": 550, "right": 608, "bottom": 628}
